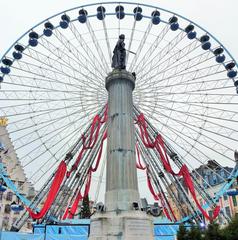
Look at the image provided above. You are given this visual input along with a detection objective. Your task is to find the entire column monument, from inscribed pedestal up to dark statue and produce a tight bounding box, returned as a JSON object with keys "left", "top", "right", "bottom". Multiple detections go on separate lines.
{"left": 89, "top": 34, "right": 153, "bottom": 240}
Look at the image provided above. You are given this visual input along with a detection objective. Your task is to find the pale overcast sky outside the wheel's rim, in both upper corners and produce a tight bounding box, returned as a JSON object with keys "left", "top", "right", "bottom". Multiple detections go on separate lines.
{"left": 0, "top": 0, "right": 238, "bottom": 59}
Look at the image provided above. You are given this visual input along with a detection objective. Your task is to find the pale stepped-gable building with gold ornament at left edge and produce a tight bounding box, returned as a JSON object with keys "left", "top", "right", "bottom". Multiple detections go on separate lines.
{"left": 0, "top": 118, "right": 35, "bottom": 231}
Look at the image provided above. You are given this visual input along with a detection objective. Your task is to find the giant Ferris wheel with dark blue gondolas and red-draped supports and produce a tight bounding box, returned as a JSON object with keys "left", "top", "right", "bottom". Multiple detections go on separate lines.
{"left": 0, "top": 2, "right": 238, "bottom": 231}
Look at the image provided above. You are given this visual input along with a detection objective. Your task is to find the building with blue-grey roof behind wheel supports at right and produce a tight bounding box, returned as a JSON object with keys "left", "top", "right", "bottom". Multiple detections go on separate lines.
{"left": 169, "top": 160, "right": 238, "bottom": 224}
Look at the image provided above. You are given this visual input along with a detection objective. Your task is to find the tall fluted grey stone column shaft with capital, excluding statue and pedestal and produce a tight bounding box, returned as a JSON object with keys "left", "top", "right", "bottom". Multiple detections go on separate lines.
{"left": 105, "top": 70, "right": 139, "bottom": 211}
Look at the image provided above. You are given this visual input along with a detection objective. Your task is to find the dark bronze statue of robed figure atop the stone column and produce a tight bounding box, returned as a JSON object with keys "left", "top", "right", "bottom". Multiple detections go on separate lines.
{"left": 112, "top": 34, "right": 126, "bottom": 69}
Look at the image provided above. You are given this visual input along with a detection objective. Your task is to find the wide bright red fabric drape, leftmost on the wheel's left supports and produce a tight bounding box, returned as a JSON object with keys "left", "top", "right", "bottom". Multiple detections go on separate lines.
{"left": 27, "top": 161, "right": 67, "bottom": 219}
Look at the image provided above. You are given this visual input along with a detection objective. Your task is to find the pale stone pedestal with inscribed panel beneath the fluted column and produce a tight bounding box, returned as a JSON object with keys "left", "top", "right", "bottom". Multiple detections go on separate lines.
{"left": 89, "top": 211, "right": 154, "bottom": 240}
